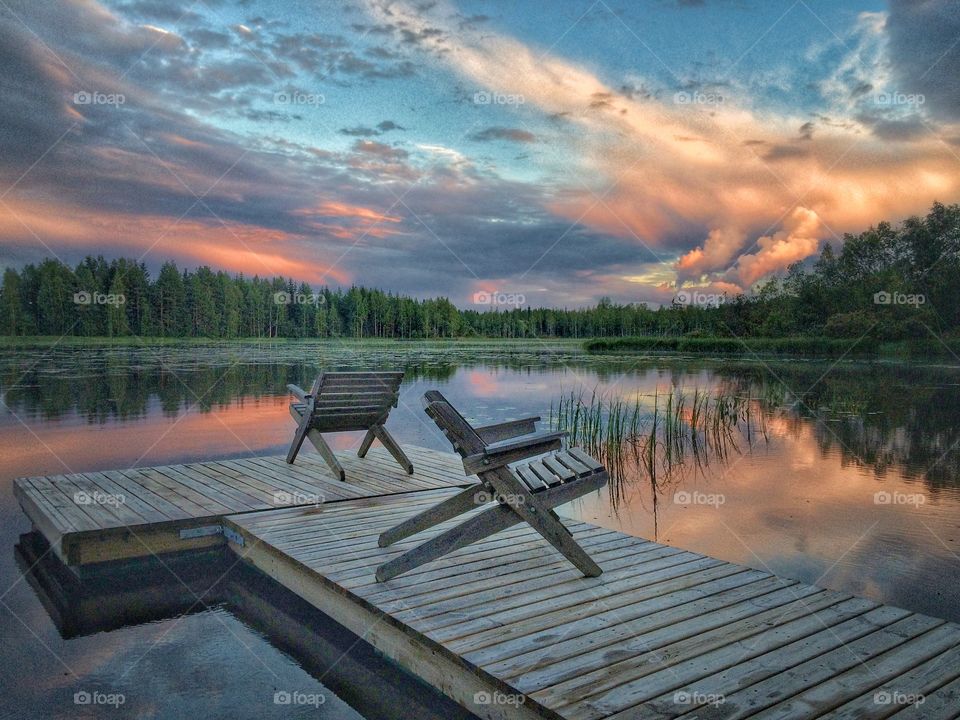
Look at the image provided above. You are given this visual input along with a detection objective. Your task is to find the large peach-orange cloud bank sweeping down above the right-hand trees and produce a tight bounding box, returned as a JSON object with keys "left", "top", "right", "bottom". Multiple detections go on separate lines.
{"left": 369, "top": 3, "right": 960, "bottom": 290}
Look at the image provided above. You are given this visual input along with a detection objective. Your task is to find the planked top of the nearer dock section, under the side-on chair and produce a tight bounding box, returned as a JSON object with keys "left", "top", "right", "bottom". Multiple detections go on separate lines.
{"left": 221, "top": 494, "right": 960, "bottom": 720}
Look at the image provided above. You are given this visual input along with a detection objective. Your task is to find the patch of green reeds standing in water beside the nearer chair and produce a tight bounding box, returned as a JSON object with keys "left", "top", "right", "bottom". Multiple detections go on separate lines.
{"left": 550, "top": 388, "right": 767, "bottom": 506}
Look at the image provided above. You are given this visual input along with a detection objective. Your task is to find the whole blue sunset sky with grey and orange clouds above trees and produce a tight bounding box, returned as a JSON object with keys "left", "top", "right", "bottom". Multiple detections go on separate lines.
{"left": 0, "top": 0, "right": 960, "bottom": 307}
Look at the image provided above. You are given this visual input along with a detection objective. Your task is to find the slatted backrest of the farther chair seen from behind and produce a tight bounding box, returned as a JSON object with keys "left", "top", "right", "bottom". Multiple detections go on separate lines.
{"left": 311, "top": 370, "right": 403, "bottom": 430}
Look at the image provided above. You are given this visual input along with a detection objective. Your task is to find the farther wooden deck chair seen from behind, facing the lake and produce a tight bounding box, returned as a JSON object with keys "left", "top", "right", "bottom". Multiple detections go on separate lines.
{"left": 287, "top": 371, "right": 413, "bottom": 480}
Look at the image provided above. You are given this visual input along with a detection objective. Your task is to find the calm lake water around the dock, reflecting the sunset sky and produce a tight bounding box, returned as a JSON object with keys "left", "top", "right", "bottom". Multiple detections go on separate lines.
{"left": 0, "top": 343, "right": 960, "bottom": 718}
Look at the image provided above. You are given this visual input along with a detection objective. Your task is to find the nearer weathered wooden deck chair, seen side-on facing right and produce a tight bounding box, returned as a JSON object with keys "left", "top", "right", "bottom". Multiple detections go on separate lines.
{"left": 376, "top": 390, "right": 608, "bottom": 582}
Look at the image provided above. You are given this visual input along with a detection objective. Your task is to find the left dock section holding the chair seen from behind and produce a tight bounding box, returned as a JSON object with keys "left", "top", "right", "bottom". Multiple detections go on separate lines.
{"left": 13, "top": 447, "right": 467, "bottom": 569}
